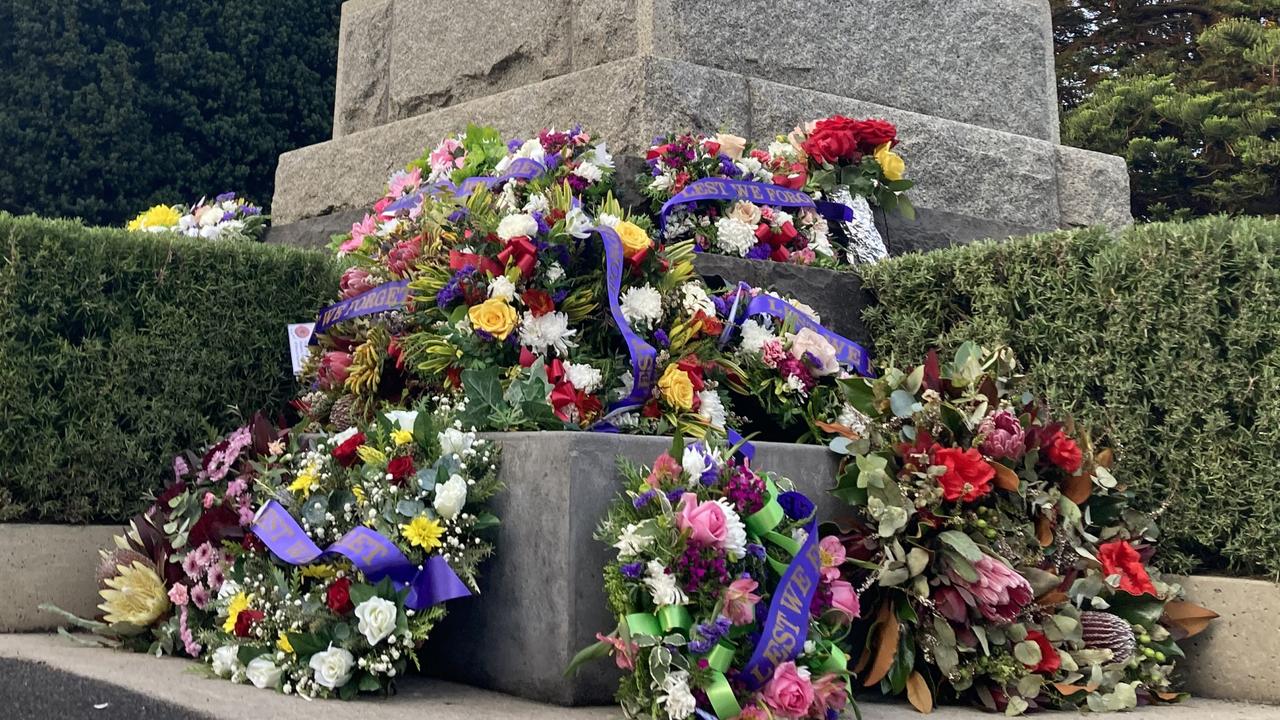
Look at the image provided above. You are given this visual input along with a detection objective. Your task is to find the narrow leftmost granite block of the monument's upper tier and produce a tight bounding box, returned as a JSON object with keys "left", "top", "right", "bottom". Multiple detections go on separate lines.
{"left": 333, "top": 0, "right": 392, "bottom": 137}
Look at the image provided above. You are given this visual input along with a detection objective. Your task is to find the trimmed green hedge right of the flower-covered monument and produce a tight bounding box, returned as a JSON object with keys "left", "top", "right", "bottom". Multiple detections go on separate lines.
{"left": 864, "top": 217, "right": 1280, "bottom": 577}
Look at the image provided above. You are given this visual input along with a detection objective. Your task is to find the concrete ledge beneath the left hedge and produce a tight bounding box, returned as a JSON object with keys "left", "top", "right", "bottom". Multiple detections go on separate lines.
{"left": 0, "top": 524, "right": 120, "bottom": 633}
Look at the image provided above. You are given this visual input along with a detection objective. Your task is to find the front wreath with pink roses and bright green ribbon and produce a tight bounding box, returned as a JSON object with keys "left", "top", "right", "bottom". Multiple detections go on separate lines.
{"left": 573, "top": 437, "right": 859, "bottom": 720}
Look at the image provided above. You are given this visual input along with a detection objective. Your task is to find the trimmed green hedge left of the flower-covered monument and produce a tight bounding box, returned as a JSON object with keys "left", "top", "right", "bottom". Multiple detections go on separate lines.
{"left": 0, "top": 213, "right": 338, "bottom": 523}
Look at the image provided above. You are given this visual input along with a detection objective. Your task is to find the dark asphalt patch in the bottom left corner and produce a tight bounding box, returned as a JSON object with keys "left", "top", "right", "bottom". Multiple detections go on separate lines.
{"left": 0, "top": 657, "right": 209, "bottom": 720}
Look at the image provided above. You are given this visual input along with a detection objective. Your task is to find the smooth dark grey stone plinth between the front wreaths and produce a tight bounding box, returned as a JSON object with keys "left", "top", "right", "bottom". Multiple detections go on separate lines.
{"left": 424, "top": 432, "right": 837, "bottom": 705}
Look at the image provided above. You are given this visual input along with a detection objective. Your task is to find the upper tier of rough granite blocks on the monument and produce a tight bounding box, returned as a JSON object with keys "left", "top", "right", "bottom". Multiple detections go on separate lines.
{"left": 334, "top": 0, "right": 1057, "bottom": 141}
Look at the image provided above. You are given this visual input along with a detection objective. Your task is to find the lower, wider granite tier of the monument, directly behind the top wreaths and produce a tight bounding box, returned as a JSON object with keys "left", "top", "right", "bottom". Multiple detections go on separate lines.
{"left": 271, "top": 56, "right": 1125, "bottom": 243}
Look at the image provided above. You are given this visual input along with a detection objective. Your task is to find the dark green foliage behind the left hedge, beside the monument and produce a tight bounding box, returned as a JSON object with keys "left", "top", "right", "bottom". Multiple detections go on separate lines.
{"left": 0, "top": 0, "right": 342, "bottom": 225}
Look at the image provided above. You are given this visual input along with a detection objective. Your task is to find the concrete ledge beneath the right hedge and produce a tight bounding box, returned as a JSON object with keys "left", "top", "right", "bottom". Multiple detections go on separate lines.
{"left": 1181, "top": 575, "right": 1280, "bottom": 702}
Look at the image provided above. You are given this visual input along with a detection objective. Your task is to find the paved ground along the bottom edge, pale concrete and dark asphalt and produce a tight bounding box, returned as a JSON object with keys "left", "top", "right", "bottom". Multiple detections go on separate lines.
{"left": 0, "top": 634, "right": 1280, "bottom": 720}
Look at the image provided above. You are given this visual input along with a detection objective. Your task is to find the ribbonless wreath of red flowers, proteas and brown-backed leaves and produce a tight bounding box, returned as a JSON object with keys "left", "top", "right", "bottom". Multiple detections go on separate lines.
{"left": 832, "top": 343, "right": 1212, "bottom": 714}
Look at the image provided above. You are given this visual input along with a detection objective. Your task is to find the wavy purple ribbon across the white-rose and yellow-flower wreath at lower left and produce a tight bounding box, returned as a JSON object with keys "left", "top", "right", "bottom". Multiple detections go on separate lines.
{"left": 252, "top": 500, "right": 471, "bottom": 610}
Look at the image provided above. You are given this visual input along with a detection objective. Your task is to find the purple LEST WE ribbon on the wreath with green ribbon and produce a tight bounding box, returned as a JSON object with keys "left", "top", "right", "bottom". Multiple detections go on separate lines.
{"left": 739, "top": 518, "right": 822, "bottom": 691}
